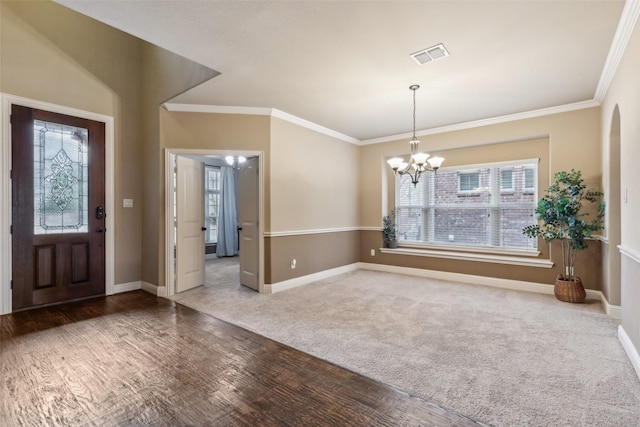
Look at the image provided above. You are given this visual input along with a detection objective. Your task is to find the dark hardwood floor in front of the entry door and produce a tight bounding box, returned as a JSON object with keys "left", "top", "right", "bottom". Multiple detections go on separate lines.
{"left": 0, "top": 291, "right": 479, "bottom": 426}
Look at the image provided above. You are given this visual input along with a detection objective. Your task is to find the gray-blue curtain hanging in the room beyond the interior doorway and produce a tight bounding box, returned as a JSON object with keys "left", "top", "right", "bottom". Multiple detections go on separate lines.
{"left": 216, "top": 166, "right": 238, "bottom": 257}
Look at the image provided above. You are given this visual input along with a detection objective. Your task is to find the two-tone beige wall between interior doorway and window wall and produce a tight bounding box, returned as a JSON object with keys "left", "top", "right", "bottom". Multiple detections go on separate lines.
{"left": 265, "top": 118, "right": 360, "bottom": 283}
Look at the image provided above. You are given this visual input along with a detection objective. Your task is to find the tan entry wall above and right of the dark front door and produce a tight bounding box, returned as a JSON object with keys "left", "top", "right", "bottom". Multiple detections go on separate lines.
{"left": 0, "top": 1, "right": 217, "bottom": 290}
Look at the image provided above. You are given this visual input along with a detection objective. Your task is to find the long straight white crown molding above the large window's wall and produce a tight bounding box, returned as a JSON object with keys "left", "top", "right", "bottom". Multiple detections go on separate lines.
{"left": 360, "top": 99, "right": 600, "bottom": 145}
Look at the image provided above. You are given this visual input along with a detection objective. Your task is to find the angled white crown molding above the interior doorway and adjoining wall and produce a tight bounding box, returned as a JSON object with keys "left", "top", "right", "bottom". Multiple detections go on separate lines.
{"left": 163, "top": 102, "right": 360, "bottom": 145}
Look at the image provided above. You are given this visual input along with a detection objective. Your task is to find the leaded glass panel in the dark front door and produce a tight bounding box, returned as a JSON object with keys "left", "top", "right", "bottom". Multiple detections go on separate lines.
{"left": 33, "top": 120, "right": 89, "bottom": 234}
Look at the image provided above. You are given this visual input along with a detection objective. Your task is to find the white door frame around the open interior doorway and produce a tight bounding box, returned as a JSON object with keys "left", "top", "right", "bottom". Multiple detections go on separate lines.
{"left": 164, "top": 148, "right": 266, "bottom": 297}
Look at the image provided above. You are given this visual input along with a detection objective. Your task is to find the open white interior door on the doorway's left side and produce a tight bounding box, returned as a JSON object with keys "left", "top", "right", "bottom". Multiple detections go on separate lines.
{"left": 176, "top": 156, "right": 205, "bottom": 292}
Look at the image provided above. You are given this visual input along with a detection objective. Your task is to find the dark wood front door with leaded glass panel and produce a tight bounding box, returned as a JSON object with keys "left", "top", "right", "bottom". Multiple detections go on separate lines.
{"left": 11, "top": 105, "right": 105, "bottom": 310}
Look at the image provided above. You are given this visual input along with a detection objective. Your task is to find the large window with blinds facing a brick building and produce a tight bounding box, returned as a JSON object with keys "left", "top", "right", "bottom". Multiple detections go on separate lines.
{"left": 396, "top": 160, "right": 537, "bottom": 250}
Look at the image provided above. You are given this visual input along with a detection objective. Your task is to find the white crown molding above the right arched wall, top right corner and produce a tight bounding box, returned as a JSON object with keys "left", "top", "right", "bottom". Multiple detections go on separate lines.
{"left": 594, "top": 0, "right": 640, "bottom": 103}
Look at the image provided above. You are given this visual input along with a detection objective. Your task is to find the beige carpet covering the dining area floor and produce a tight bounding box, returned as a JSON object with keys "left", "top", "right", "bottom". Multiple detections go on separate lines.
{"left": 175, "top": 266, "right": 640, "bottom": 426}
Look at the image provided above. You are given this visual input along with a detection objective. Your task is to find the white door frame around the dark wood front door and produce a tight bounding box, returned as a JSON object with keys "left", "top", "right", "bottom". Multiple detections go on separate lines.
{"left": 0, "top": 93, "right": 115, "bottom": 315}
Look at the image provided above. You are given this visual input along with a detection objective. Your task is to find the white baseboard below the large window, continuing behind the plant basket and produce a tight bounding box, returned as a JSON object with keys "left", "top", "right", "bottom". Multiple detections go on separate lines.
{"left": 358, "top": 262, "right": 622, "bottom": 320}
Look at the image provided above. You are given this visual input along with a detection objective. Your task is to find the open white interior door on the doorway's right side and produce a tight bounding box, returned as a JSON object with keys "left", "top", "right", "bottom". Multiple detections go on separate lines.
{"left": 238, "top": 157, "right": 259, "bottom": 291}
